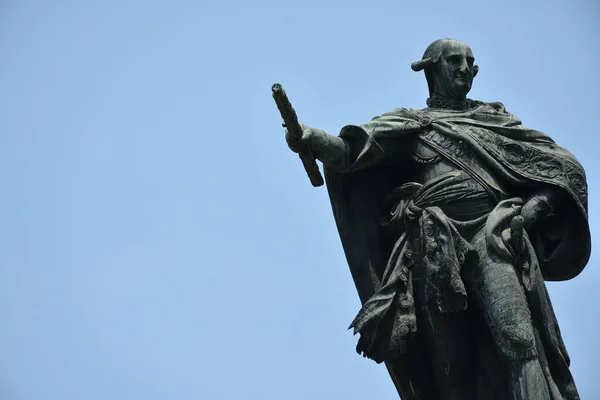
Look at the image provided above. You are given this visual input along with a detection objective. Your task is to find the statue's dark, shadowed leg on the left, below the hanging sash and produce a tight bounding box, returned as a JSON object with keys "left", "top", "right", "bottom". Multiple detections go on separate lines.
{"left": 413, "top": 266, "right": 475, "bottom": 400}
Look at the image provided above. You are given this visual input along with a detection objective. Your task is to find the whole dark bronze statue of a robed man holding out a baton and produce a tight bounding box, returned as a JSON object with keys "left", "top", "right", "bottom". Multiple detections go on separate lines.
{"left": 274, "top": 39, "right": 590, "bottom": 400}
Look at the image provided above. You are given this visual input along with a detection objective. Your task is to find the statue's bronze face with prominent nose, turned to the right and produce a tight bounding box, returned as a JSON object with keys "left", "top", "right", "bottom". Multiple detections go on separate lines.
{"left": 435, "top": 41, "right": 477, "bottom": 99}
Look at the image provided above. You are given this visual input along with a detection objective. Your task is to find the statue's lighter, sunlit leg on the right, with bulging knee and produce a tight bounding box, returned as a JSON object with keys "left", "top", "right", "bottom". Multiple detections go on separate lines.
{"left": 465, "top": 237, "right": 550, "bottom": 400}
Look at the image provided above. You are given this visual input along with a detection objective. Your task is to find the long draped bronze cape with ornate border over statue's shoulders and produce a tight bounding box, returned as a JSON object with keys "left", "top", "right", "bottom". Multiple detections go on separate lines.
{"left": 325, "top": 102, "right": 591, "bottom": 399}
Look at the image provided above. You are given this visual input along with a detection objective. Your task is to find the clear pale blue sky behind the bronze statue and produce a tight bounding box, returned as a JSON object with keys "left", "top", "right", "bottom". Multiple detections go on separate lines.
{"left": 0, "top": 0, "right": 600, "bottom": 400}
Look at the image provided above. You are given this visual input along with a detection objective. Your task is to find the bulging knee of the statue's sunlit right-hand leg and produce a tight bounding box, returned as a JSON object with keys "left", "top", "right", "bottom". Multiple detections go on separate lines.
{"left": 497, "top": 321, "right": 537, "bottom": 360}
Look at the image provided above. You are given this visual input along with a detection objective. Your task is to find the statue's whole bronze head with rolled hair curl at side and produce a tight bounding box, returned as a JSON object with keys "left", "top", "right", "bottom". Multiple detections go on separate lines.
{"left": 411, "top": 39, "right": 479, "bottom": 100}
